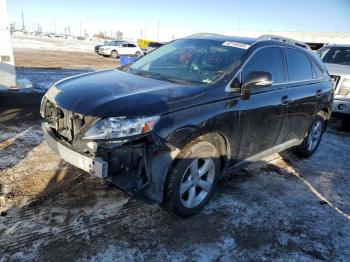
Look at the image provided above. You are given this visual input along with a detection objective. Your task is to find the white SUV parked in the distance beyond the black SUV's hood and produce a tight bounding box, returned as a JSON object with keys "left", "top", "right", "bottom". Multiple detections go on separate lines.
{"left": 98, "top": 42, "right": 142, "bottom": 59}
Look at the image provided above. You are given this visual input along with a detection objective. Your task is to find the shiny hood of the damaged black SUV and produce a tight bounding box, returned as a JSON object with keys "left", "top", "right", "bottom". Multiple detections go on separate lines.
{"left": 46, "top": 69, "right": 205, "bottom": 117}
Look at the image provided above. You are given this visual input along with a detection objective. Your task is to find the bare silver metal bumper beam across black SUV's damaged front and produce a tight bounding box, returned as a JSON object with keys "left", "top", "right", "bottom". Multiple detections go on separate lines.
{"left": 42, "top": 123, "right": 108, "bottom": 178}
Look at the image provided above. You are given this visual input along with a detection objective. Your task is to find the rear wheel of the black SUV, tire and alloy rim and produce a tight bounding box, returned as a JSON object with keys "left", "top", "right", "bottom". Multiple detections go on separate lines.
{"left": 293, "top": 115, "right": 325, "bottom": 158}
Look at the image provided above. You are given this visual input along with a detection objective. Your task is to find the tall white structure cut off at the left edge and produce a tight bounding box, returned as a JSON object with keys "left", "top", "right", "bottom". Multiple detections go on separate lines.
{"left": 0, "top": 0, "right": 17, "bottom": 90}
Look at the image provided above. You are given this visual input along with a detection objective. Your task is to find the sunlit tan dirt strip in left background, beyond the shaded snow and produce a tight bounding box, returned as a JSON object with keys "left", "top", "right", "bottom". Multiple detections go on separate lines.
{"left": 14, "top": 48, "right": 120, "bottom": 69}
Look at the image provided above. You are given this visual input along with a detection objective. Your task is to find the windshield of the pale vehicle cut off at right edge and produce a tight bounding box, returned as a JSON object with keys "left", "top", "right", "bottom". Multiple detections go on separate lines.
{"left": 318, "top": 47, "right": 350, "bottom": 65}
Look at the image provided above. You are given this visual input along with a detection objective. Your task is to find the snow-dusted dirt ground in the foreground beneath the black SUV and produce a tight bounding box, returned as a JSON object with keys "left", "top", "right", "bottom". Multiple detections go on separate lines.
{"left": 0, "top": 115, "right": 350, "bottom": 261}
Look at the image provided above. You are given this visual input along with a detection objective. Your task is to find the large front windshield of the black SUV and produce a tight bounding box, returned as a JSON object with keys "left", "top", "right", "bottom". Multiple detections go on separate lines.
{"left": 129, "top": 39, "right": 245, "bottom": 84}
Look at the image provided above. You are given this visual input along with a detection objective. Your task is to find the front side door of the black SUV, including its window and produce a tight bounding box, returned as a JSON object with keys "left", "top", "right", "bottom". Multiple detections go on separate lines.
{"left": 232, "top": 47, "right": 288, "bottom": 160}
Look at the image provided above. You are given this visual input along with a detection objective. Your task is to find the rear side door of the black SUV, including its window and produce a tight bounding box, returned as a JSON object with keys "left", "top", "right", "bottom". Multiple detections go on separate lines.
{"left": 284, "top": 47, "right": 329, "bottom": 140}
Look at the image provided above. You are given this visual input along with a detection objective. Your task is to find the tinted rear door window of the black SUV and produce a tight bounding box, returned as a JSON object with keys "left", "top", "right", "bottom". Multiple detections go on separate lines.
{"left": 285, "top": 48, "right": 313, "bottom": 81}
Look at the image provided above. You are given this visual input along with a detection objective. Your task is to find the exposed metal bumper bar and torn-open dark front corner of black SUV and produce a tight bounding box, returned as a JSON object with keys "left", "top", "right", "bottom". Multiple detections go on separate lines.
{"left": 42, "top": 123, "right": 179, "bottom": 203}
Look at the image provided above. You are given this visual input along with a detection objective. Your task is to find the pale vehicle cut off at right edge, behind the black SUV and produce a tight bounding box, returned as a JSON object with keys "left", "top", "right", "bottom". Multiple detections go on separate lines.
{"left": 317, "top": 45, "right": 350, "bottom": 129}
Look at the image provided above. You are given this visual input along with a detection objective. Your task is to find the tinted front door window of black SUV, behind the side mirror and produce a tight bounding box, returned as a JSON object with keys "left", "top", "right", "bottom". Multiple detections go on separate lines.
{"left": 242, "top": 47, "right": 285, "bottom": 84}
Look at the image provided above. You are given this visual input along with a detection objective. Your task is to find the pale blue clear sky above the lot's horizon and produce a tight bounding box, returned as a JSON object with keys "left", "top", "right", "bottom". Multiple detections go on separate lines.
{"left": 7, "top": 0, "right": 350, "bottom": 41}
